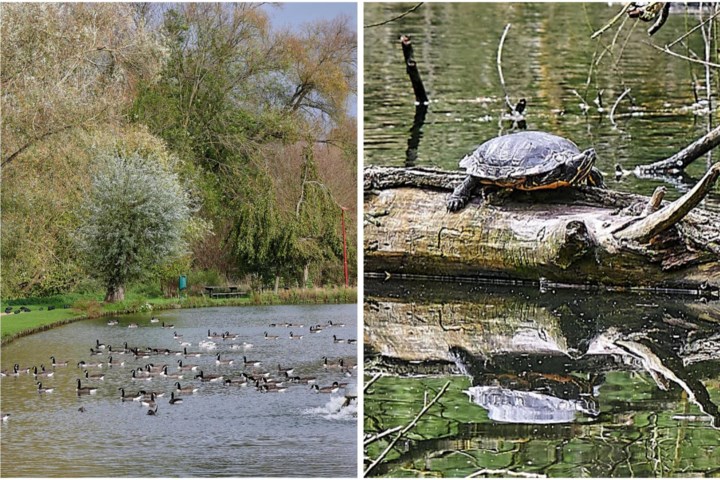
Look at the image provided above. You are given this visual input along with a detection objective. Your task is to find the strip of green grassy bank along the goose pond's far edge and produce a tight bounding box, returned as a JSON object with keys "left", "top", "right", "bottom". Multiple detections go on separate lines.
{"left": 0, "top": 288, "right": 357, "bottom": 345}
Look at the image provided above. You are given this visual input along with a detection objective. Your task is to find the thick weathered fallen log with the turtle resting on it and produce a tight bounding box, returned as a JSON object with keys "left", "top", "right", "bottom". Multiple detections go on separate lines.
{"left": 364, "top": 164, "right": 720, "bottom": 290}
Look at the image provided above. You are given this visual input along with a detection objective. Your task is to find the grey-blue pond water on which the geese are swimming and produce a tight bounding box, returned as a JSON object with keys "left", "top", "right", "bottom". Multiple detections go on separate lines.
{"left": 2, "top": 305, "right": 357, "bottom": 477}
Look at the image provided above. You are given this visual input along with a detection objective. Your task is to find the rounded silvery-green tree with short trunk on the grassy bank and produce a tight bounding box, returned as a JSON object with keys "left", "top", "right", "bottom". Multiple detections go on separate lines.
{"left": 78, "top": 152, "right": 191, "bottom": 302}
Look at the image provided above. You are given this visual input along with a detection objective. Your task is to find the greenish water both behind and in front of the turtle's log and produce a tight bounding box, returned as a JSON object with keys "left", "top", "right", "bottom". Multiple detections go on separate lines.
{"left": 364, "top": 2, "right": 720, "bottom": 477}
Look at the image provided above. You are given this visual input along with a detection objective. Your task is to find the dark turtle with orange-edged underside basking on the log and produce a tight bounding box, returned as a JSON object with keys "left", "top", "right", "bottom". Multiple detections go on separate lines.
{"left": 447, "top": 131, "right": 604, "bottom": 212}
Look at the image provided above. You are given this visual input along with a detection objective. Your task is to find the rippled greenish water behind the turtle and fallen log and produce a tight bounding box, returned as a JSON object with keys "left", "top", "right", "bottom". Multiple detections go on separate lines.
{"left": 364, "top": 3, "right": 720, "bottom": 211}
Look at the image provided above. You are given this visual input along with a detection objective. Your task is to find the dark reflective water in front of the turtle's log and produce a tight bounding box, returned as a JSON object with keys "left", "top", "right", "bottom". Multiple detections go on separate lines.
{"left": 364, "top": 280, "right": 720, "bottom": 478}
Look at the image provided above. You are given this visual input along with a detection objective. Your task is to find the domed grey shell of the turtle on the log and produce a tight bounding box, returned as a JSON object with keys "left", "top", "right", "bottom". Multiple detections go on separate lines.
{"left": 460, "top": 132, "right": 581, "bottom": 181}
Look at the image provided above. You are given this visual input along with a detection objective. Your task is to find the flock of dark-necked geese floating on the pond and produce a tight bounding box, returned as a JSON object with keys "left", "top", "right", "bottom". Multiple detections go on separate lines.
{"left": 0, "top": 317, "right": 357, "bottom": 422}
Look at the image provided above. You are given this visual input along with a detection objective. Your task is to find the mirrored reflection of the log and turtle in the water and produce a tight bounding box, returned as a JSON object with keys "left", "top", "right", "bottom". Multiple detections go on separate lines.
{"left": 365, "top": 284, "right": 720, "bottom": 428}
